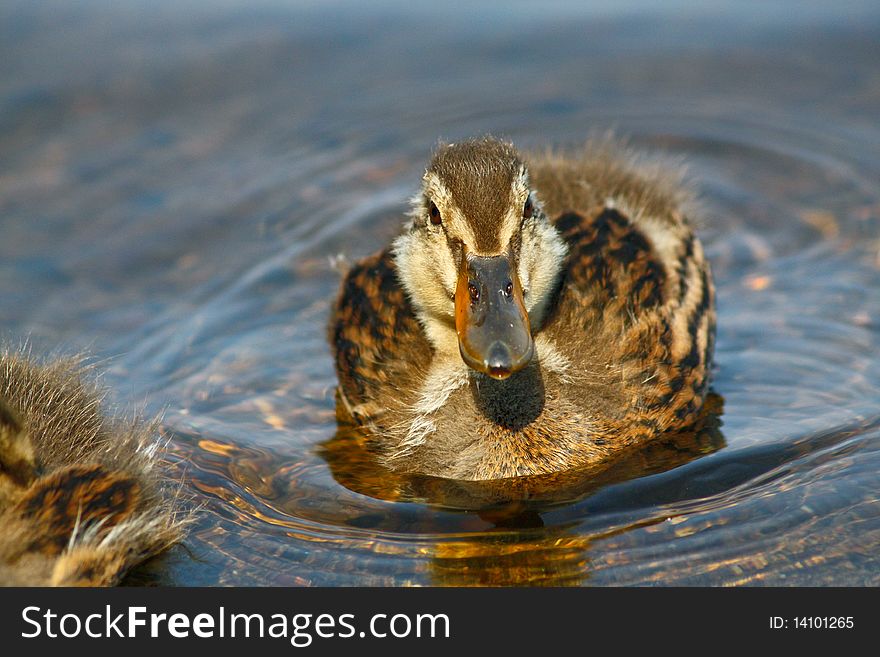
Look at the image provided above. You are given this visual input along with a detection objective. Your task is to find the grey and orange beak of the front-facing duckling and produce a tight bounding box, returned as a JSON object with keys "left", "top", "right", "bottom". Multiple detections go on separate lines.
{"left": 455, "top": 255, "right": 535, "bottom": 379}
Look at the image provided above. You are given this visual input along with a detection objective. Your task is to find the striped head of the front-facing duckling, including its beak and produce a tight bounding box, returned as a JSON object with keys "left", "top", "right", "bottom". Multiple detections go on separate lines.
{"left": 394, "top": 138, "right": 566, "bottom": 379}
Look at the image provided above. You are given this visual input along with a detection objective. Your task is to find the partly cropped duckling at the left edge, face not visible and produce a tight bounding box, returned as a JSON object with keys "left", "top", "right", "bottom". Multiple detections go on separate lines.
{"left": 0, "top": 351, "right": 188, "bottom": 586}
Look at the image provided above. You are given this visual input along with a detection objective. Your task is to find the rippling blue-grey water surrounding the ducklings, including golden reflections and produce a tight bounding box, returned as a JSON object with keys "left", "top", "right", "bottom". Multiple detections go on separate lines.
{"left": 0, "top": 0, "right": 880, "bottom": 585}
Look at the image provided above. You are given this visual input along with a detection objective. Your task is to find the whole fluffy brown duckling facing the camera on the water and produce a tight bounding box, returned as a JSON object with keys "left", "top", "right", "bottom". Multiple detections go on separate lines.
{"left": 329, "top": 137, "right": 715, "bottom": 480}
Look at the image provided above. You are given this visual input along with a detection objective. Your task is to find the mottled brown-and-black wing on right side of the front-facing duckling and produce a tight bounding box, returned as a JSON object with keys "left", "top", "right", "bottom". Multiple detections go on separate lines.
{"left": 547, "top": 202, "right": 715, "bottom": 434}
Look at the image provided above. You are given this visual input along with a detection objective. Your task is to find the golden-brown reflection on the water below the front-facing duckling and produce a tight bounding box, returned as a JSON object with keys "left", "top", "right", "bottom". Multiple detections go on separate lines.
{"left": 320, "top": 393, "right": 725, "bottom": 586}
